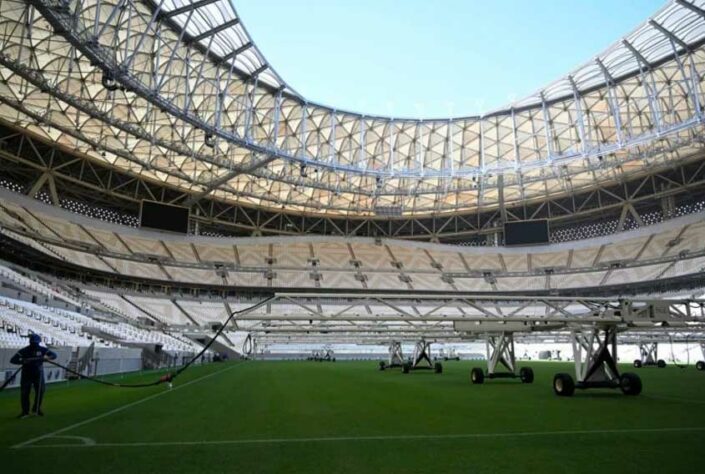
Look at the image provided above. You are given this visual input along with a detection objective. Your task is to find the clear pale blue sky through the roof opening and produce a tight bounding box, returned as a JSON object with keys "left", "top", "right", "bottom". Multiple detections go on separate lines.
{"left": 233, "top": 0, "right": 665, "bottom": 118}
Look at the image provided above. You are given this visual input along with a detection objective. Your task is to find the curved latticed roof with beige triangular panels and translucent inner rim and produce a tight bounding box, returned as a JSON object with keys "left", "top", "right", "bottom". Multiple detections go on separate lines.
{"left": 0, "top": 0, "right": 705, "bottom": 218}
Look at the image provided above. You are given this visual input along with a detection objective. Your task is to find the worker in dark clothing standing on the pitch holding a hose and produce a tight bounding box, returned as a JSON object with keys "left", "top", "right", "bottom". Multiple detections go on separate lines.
{"left": 10, "top": 334, "right": 56, "bottom": 418}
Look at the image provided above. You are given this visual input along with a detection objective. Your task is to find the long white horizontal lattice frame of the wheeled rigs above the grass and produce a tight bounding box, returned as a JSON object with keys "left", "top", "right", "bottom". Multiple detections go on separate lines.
{"left": 230, "top": 293, "right": 705, "bottom": 342}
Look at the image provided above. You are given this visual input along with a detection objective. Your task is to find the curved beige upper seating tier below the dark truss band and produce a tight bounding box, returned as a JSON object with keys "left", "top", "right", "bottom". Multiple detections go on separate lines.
{"left": 0, "top": 190, "right": 705, "bottom": 292}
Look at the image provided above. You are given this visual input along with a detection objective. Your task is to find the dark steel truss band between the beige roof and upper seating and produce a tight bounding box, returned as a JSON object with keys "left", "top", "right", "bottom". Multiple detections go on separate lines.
{"left": 0, "top": 126, "right": 705, "bottom": 244}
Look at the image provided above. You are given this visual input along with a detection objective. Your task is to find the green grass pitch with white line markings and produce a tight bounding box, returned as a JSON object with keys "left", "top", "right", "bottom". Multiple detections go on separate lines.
{"left": 0, "top": 362, "right": 705, "bottom": 474}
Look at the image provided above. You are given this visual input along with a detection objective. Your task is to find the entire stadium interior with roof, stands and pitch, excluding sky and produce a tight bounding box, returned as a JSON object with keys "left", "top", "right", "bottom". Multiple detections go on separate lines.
{"left": 0, "top": 0, "right": 705, "bottom": 473}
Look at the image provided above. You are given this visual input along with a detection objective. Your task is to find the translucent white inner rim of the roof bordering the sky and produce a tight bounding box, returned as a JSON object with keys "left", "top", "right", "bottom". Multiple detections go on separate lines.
{"left": 155, "top": 0, "right": 703, "bottom": 113}
